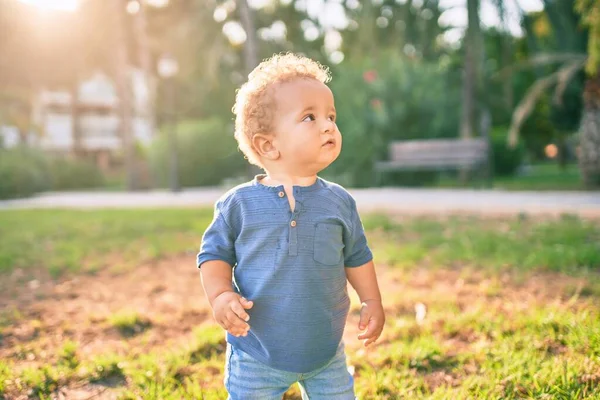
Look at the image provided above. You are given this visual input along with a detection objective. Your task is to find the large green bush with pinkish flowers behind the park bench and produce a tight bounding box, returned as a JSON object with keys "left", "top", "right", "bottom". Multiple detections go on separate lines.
{"left": 326, "top": 51, "right": 459, "bottom": 186}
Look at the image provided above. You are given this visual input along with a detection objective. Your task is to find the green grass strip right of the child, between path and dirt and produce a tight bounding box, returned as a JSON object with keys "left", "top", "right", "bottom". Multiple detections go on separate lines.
{"left": 364, "top": 215, "right": 600, "bottom": 273}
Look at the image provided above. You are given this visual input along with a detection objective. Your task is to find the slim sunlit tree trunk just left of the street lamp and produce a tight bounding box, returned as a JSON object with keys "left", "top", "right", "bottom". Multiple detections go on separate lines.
{"left": 112, "top": 0, "right": 136, "bottom": 190}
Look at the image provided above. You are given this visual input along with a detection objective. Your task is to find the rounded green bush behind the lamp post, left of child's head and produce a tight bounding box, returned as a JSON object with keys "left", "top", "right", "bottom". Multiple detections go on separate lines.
{"left": 148, "top": 118, "right": 247, "bottom": 186}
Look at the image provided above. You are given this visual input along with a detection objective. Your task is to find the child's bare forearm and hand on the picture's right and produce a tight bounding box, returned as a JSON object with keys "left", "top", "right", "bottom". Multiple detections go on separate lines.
{"left": 346, "top": 261, "right": 385, "bottom": 346}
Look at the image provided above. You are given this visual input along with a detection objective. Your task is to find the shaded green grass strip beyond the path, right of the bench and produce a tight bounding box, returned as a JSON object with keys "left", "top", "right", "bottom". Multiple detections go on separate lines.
{"left": 435, "top": 163, "right": 583, "bottom": 191}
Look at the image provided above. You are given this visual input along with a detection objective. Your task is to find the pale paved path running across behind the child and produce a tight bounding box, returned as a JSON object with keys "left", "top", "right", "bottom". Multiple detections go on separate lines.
{"left": 0, "top": 188, "right": 600, "bottom": 217}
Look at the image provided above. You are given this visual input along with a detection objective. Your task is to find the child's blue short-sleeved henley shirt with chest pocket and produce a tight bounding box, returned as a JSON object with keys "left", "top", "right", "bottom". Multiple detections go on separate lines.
{"left": 197, "top": 177, "right": 373, "bottom": 373}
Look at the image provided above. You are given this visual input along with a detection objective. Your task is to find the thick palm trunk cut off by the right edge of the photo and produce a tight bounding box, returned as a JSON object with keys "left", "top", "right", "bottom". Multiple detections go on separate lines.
{"left": 577, "top": 71, "right": 600, "bottom": 189}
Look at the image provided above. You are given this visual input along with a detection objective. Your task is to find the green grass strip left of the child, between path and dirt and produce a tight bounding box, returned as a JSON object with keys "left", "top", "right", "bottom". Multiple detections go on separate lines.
{"left": 0, "top": 209, "right": 212, "bottom": 277}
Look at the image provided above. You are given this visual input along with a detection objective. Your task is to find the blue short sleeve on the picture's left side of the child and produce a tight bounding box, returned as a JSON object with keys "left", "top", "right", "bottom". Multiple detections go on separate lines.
{"left": 196, "top": 202, "right": 236, "bottom": 268}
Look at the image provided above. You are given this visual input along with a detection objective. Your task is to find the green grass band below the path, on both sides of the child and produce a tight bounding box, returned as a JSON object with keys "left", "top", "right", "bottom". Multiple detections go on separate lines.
{"left": 0, "top": 209, "right": 600, "bottom": 277}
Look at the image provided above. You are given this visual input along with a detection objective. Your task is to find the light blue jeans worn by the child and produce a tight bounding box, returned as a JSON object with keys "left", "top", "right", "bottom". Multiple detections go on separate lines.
{"left": 224, "top": 343, "right": 355, "bottom": 400}
